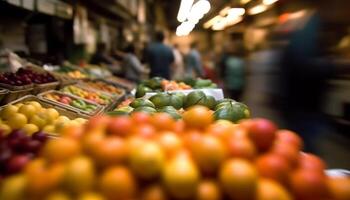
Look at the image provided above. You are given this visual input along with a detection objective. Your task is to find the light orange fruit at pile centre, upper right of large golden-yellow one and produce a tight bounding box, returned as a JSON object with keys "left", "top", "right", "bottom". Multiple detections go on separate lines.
{"left": 157, "top": 131, "right": 183, "bottom": 158}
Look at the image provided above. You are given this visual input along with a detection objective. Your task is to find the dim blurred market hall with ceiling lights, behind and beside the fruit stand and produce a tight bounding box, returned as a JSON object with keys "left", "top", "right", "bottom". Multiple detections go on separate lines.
{"left": 0, "top": 0, "right": 350, "bottom": 169}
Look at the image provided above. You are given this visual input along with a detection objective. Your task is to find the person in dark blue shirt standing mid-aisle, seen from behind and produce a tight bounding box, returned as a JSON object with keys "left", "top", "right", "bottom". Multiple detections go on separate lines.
{"left": 145, "top": 31, "right": 174, "bottom": 79}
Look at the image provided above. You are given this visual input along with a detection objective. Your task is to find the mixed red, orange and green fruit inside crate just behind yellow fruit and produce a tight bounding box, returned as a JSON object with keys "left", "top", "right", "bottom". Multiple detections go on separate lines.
{"left": 43, "top": 92, "right": 99, "bottom": 114}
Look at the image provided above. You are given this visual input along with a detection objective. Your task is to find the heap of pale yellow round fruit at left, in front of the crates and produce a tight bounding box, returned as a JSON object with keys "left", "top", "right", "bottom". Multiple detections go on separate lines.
{"left": 0, "top": 101, "right": 86, "bottom": 135}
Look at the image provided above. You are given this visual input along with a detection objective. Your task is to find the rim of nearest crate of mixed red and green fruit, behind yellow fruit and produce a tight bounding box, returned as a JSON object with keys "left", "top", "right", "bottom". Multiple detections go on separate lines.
{"left": 38, "top": 90, "right": 103, "bottom": 116}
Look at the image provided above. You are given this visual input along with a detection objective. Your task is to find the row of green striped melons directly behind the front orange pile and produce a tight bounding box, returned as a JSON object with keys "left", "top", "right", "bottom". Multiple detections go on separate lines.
{"left": 108, "top": 91, "right": 250, "bottom": 122}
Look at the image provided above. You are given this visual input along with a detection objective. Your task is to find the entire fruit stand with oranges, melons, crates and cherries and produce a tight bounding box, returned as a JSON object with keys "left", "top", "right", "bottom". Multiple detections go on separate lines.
{"left": 0, "top": 58, "right": 350, "bottom": 200}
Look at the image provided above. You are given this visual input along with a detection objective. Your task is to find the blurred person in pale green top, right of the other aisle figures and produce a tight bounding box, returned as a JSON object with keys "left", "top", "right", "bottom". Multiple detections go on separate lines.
{"left": 223, "top": 42, "right": 245, "bottom": 101}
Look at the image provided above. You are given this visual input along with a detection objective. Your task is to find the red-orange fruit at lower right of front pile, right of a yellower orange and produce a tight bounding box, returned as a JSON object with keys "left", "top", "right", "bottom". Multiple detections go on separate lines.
{"left": 255, "top": 153, "right": 291, "bottom": 183}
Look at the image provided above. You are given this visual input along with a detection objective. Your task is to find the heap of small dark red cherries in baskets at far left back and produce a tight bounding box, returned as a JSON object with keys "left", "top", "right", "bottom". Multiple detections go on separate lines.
{"left": 0, "top": 68, "right": 56, "bottom": 86}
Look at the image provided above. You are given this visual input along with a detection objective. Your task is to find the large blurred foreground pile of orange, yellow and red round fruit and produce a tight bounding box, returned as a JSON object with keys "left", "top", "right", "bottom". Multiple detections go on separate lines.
{"left": 0, "top": 106, "right": 350, "bottom": 200}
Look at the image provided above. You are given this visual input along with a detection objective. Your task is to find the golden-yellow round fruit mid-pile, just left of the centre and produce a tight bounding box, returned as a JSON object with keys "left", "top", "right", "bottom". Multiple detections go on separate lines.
{"left": 129, "top": 141, "right": 165, "bottom": 180}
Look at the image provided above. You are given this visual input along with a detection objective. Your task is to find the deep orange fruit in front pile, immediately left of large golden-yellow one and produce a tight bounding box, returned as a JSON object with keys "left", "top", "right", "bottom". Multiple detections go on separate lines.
{"left": 92, "top": 136, "right": 128, "bottom": 166}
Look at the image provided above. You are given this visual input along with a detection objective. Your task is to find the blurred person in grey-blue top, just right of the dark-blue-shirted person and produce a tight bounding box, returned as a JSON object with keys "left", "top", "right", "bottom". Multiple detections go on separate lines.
{"left": 185, "top": 42, "right": 204, "bottom": 78}
